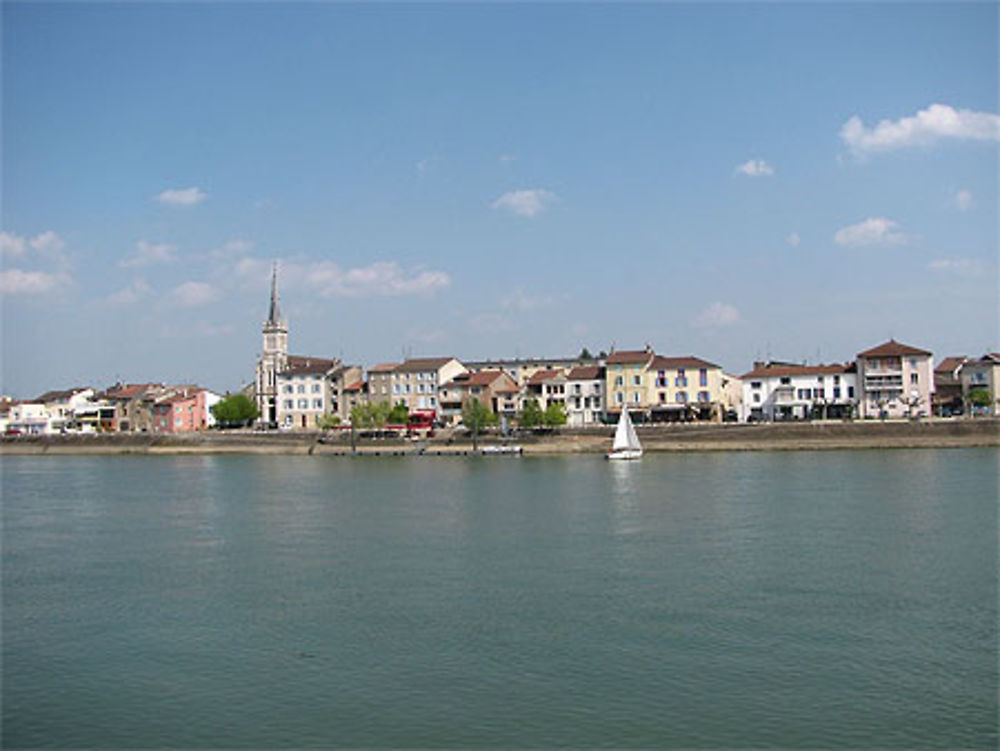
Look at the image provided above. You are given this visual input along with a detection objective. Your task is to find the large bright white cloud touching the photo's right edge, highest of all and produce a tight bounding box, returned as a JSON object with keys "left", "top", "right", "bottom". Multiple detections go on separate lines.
{"left": 840, "top": 104, "right": 1000, "bottom": 156}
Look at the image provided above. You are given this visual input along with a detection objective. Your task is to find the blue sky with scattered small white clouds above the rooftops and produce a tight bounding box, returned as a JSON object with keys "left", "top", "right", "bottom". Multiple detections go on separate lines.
{"left": 0, "top": 2, "right": 1000, "bottom": 398}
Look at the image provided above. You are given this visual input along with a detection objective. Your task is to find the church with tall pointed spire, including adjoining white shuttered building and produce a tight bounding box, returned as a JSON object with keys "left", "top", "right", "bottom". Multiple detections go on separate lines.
{"left": 254, "top": 264, "right": 364, "bottom": 430}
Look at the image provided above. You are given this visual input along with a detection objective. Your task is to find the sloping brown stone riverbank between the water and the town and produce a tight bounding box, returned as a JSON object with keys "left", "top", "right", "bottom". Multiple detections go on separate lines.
{"left": 0, "top": 419, "right": 1000, "bottom": 456}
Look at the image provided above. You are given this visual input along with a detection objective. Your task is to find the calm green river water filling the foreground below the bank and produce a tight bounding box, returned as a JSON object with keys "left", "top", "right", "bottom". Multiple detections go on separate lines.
{"left": 0, "top": 449, "right": 1000, "bottom": 749}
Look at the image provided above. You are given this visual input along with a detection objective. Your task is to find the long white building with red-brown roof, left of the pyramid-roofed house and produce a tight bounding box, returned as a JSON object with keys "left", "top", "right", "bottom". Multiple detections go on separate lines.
{"left": 740, "top": 362, "right": 857, "bottom": 422}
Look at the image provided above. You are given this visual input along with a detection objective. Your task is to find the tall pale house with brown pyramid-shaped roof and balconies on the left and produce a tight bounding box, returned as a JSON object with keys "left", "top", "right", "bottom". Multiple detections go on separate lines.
{"left": 856, "top": 339, "right": 934, "bottom": 418}
